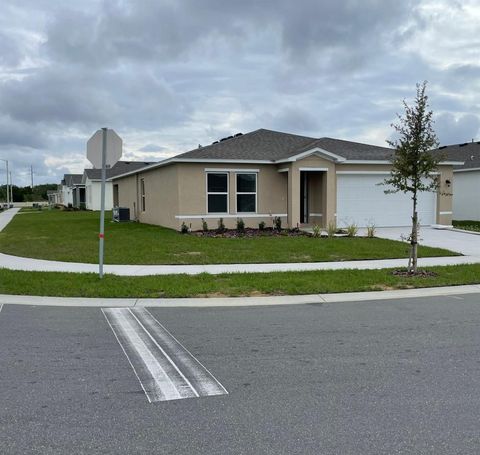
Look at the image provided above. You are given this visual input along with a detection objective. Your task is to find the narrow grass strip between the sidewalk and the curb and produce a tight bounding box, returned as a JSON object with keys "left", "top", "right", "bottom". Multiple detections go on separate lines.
{"left": 0, "top": 264, "right": 480, "bottom": 298}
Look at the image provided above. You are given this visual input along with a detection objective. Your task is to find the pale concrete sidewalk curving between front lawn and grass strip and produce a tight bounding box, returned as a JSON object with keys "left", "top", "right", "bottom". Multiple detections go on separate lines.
{"left": 0, "top": 209, "right": 480, "bottom": 276}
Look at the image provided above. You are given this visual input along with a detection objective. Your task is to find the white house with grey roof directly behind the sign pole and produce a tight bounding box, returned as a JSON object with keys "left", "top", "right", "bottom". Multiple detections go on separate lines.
{"left": 82, "top": 161, "right": 154, "bottom": 210}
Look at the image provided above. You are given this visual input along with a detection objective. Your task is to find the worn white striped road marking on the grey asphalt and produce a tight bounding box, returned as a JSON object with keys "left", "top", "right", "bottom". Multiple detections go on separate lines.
{"left": 102, "top": 308, "right": 228, "bottom": 403}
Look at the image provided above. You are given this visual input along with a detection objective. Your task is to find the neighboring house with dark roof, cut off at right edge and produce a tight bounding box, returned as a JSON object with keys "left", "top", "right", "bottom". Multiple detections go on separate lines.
{"left": 439, "top": 142, "right": 480, "bottom": 221}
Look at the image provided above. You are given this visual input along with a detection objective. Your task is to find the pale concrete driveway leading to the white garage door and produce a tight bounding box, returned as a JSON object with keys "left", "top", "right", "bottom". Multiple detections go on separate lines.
{"left": 370, "top": 227, "right": 480, "bottom": 257}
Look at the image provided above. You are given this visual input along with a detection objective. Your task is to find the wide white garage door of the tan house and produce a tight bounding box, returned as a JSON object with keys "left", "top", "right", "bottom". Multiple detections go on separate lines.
{"left": 337, "top": 174, "right": 436, "bottom": 227}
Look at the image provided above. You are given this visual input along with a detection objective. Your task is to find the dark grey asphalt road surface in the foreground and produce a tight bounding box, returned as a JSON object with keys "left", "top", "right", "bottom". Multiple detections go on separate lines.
{"left": 0, "top": 295, "right": 480, "bottom": 455}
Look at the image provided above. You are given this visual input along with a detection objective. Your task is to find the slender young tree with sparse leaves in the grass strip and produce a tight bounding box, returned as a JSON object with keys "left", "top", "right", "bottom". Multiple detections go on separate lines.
{"left": 383, "top": 81, "right": 442, "bottom": 273}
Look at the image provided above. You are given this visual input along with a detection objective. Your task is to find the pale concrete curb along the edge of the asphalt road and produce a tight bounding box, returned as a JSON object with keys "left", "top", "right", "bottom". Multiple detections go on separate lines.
{"left": 0, "top": 284, "right": 480, "bottom": 308}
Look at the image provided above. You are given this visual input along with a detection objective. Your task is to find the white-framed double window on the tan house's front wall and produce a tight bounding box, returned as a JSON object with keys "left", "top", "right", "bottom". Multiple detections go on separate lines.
{"left": 207, "top": 172, "right": 257, "bottom": 214}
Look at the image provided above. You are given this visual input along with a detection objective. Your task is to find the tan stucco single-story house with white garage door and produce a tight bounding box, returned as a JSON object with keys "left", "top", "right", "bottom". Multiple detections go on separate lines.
{"left": 112, "top": 129, "right": 461, "bottom": 229}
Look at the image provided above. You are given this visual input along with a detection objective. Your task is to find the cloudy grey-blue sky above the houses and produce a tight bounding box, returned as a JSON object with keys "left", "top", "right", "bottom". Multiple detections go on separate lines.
{"left": 0, "top": 0, "right": 480, "bottom": 185}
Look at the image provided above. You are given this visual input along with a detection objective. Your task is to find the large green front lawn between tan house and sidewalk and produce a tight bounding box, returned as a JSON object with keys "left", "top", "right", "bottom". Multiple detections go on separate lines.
{"left": 0, "top": 209, "right": 455, "bottom": 264}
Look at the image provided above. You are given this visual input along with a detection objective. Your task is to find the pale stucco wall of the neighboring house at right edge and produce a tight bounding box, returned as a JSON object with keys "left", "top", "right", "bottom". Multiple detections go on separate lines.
{"left": 453, "top": 171, "right": 480, "bottom": 221}
